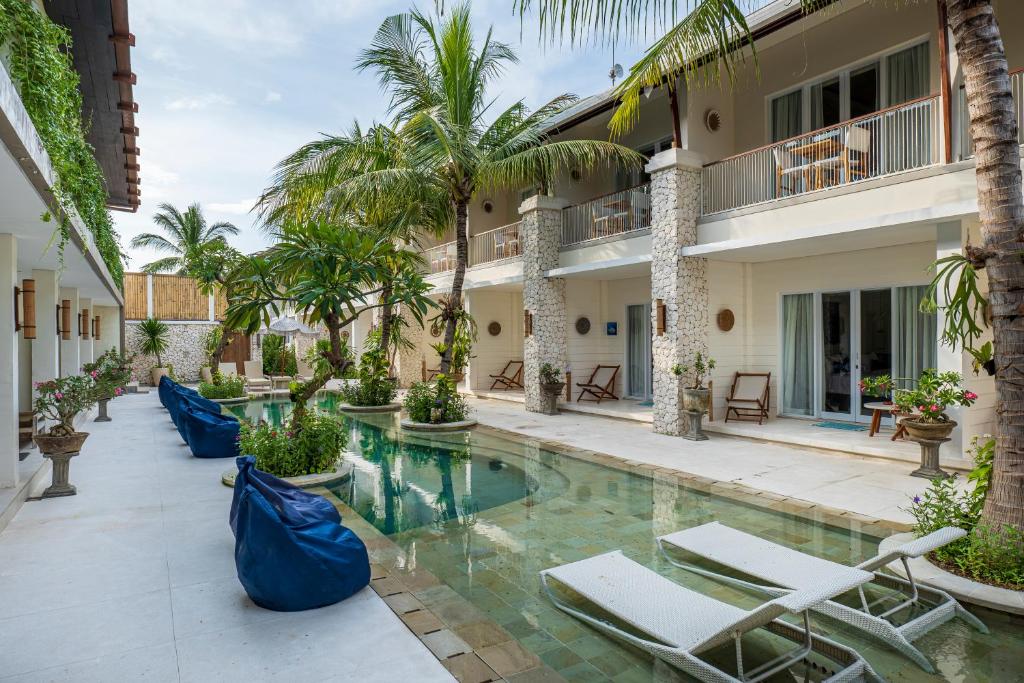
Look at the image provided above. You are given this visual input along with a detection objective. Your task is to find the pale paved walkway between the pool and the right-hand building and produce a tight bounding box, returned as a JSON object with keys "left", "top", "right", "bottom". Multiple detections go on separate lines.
{"left": 470, "top": 398, "right": 962, "bottom": 523}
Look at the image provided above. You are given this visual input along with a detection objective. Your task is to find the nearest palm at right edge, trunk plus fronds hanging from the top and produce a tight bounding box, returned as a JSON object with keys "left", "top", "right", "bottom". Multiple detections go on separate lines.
{"left": 516, "top": 0, "right": 1024, "bottom": 530}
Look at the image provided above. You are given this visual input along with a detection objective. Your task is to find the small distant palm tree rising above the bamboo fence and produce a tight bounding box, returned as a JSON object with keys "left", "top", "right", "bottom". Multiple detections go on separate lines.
{"left": 131, "top": 203, "right": 239, "bottom": 275}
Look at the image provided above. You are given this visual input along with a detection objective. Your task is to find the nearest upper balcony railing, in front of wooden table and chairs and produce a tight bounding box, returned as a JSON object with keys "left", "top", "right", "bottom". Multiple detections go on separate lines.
{"left": 701, "top": 95, "right": 942, "bottom": 214}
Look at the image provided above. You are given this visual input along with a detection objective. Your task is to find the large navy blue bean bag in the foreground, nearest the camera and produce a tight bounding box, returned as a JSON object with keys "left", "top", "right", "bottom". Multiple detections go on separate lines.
{"left": 228, "top": 456, "right": 370, "bottom": 611}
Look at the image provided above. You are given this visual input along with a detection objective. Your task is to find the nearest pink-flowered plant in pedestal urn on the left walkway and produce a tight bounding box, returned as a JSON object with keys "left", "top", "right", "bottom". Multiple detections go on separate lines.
{"left": 32, "top": 375, "right": 96, "bottom": 498}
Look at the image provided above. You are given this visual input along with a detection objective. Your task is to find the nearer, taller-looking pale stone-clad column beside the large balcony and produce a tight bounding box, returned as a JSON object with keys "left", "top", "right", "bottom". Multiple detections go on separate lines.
{"left": 647, "top": 150, "right": 708, "bottom": 435}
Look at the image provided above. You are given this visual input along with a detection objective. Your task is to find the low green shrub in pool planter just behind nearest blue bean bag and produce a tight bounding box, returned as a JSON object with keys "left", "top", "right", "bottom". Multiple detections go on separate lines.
{"left": 239, "top": 412, "right": 347, "bottom": 477}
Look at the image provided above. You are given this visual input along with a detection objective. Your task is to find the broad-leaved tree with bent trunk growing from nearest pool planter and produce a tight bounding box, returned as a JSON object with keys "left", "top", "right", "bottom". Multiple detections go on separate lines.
{"left": 225, "top": 221, "right": 432, "bottom": 425}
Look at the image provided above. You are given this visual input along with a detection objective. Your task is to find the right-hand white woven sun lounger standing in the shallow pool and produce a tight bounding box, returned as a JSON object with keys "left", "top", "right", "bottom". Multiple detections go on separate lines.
{"left": 657, "top": 522, "right": 988, "bottom": 673}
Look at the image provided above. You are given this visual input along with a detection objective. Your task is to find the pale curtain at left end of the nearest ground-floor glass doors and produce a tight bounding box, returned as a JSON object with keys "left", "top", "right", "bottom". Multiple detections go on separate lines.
{"left": 782, "top": 294, "right": 814, "bottom": 415}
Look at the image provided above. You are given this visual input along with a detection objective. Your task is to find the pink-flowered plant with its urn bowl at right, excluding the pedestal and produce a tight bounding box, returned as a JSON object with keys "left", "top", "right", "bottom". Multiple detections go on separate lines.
{"left": 893, "top": 370, "right": 978, "bottom": 441}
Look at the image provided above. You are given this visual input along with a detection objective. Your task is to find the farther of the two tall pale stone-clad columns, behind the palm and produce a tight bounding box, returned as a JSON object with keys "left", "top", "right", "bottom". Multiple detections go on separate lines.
{"left": 519, "top": 196, "right": 568, "bottom": 413}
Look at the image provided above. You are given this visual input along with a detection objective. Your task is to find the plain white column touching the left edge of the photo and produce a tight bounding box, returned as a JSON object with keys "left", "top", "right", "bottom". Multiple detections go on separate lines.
{"left": 0, "top": 234, "right": 20, "bottom": 488}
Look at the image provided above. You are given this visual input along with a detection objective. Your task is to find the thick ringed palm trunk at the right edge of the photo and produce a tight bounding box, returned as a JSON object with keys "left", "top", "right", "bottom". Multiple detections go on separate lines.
{"left": 948, "top": 0, "right": 1024, "bottom": 530}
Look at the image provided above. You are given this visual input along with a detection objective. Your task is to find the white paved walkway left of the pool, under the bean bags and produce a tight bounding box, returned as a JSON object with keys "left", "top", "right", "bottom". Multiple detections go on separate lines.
{"left": 0, "top": 391, "right": 453, "bottom": 683}
